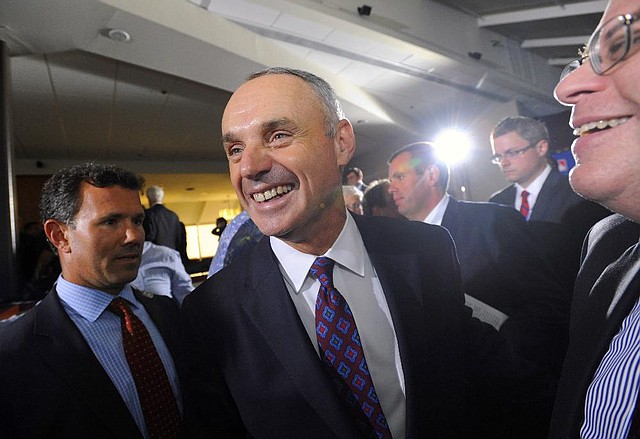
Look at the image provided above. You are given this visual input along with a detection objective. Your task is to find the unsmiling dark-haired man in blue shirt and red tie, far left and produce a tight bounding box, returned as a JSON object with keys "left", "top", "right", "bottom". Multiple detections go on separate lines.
{"left": 0, "top": 163, "right": 181, "bottom": 438}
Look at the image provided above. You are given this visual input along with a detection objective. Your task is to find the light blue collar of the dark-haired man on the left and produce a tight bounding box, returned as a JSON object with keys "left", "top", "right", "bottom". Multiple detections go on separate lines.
{"left": 56, "top": 275, "right": 138, "bottom": 322}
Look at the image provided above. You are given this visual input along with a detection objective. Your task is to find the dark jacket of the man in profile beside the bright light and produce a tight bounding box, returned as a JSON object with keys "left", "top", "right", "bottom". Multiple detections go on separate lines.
{"left": 442, "top": 198, "right": 570, "bottom": 372}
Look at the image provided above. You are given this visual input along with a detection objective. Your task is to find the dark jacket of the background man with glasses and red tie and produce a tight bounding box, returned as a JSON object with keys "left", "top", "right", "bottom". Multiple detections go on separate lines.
{"left": 489, "top": 169, "right": 611, "bottom": 292}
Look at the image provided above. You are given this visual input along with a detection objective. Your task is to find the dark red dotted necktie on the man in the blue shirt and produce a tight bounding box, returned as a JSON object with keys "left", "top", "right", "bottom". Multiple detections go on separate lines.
{"left": 108, "top": 297, "right": 181, "bottom": 439}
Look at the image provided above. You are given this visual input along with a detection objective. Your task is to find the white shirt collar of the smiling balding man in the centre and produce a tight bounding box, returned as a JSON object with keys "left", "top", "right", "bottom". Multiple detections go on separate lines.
{"left": 269, "top": 212, "right": 365, "bottom": 293}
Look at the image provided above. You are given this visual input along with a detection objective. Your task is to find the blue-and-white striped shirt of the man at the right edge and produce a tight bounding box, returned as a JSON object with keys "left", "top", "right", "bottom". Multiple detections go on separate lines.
{"left": 580, "top": 292, "right": 640, "bottom": 439}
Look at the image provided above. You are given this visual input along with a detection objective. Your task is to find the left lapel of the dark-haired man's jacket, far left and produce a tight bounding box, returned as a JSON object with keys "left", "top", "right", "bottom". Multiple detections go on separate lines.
{"left": 33, "top": 288, "right": 139, "bottom": 437}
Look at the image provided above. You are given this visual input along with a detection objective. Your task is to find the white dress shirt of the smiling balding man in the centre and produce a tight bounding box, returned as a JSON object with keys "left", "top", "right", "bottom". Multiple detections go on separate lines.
{"left": 270, "top": 213, "right": 406, "bottom": 439}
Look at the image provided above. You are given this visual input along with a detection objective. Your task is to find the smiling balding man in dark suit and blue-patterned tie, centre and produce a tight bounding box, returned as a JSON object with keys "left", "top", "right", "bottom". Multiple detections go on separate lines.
{"left": 181, "top": 68, "right": 556, "bottom": 439}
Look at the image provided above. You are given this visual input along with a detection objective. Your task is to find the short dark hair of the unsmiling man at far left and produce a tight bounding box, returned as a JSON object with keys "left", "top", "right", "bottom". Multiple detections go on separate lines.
{"left": 40, "top": 162, "right": 144, "bottom": 224}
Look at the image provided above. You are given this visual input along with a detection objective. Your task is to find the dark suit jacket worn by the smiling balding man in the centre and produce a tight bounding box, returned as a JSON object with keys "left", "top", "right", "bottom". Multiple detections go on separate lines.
{"left": 181, "top": 215, "right": 552, "bottom": 439}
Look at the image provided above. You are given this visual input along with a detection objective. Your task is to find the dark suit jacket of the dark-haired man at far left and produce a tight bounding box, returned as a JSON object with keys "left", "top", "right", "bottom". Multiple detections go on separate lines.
{"left": 0, "top": 288, "right": 178, "bottom": 439}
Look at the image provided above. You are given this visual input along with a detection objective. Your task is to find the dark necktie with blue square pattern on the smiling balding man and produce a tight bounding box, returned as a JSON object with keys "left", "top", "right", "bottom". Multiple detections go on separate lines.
{"left": 310, "top": 256, "right": 391, "bottom": 439}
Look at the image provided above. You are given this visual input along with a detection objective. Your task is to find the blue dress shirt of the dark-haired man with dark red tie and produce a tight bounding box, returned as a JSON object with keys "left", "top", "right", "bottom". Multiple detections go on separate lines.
{"left": 56, "top": 276, "right": 181, "bottom": 438}
